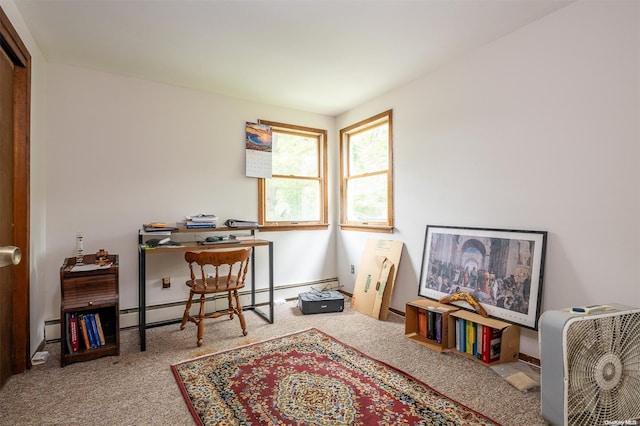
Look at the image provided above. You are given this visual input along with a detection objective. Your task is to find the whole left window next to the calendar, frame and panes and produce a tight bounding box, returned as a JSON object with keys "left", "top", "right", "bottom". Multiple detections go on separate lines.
{"left": 258, "top": 120, "right": 327, "bottom": 230}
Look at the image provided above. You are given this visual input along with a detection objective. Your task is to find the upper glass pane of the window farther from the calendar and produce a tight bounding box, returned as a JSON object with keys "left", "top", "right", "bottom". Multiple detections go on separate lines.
{"left": 349, "top": 123, "right": 389, "bottom": 176}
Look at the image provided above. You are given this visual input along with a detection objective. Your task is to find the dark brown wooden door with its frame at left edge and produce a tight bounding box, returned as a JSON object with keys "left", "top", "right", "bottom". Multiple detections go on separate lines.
{"left": 0, "top": 8, "right": 31, "bottom": 387}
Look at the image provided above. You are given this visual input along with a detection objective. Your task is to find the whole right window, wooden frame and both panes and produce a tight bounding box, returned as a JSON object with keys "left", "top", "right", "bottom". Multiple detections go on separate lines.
{"left": 340, "top": 110, "right": 393, "bottom": 232}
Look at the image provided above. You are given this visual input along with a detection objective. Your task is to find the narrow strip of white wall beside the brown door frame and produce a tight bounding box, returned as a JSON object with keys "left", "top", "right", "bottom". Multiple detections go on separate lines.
{"left": 0, "top": 0, "right": 47, "bottom": 360}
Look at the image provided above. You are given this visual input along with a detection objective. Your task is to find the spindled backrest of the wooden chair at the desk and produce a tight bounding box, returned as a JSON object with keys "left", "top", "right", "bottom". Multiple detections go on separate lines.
{"left": 184, "top": 247, "right": 253, "bottom": 288}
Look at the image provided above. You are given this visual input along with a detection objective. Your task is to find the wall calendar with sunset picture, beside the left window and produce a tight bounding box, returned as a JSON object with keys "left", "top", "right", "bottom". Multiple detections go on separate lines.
{"left": 245, "top": 122, "right": 273, "bottom": 178}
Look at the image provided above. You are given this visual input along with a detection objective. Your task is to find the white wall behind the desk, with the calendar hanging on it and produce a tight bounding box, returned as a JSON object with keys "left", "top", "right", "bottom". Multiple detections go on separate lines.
{"left": 45, "top": 64, "right": 337, "bottom": 332}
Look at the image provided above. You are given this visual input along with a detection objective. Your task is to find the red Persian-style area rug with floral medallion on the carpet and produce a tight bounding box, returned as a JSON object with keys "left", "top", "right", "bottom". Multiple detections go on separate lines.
{"left": 171, "top": 329, "right": 497, "bottom": 426}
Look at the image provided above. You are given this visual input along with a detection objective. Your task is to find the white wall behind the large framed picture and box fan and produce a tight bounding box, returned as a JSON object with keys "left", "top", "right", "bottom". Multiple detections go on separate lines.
{"left": 337, "top": 1, "right": 640, "bottom": 357}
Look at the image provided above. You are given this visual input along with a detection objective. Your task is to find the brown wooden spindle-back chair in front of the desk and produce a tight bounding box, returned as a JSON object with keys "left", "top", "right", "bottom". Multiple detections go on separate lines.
{"left": 180, "top": 247, "right": 252, "bottom": 346}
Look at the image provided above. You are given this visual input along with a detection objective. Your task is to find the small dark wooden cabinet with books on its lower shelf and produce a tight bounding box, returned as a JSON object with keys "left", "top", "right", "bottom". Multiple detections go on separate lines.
{"left": 60, "top": 255, "right": 120, "bottom": 367}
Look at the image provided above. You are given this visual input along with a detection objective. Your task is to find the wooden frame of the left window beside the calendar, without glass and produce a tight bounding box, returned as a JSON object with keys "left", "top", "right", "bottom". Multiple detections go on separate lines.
{"left": 258, "top": 120, "right": 329, "bottom": 232}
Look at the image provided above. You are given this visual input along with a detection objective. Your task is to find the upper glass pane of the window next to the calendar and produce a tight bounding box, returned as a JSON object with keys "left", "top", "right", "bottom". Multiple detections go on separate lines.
{"left": 272, "top": 130, "right": 319, "bottom": 177}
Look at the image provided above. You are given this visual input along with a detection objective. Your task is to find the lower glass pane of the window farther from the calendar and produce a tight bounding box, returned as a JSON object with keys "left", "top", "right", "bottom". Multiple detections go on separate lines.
{"left": 347, "top": 173, "right": 388, "bottom": 222}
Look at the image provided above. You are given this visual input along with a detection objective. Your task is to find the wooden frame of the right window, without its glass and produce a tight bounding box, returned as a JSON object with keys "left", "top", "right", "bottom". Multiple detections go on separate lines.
{"left": 340, "top": 109, "right": 393, "bottom": 233}
